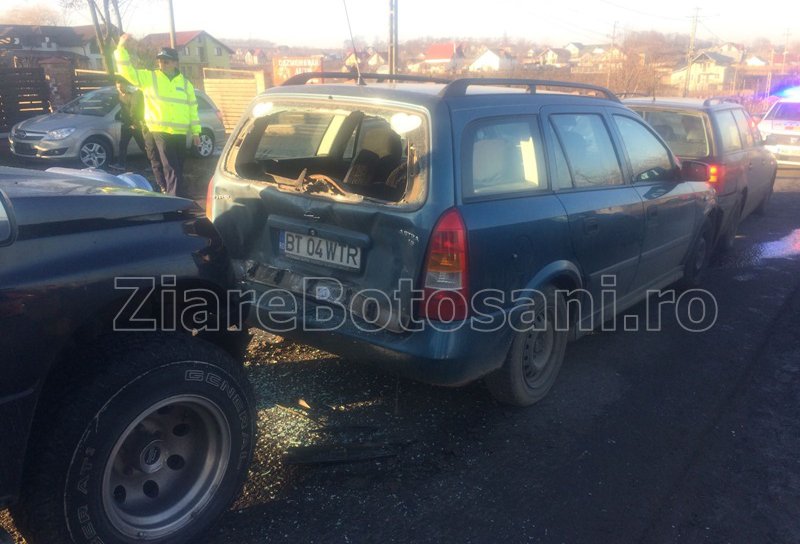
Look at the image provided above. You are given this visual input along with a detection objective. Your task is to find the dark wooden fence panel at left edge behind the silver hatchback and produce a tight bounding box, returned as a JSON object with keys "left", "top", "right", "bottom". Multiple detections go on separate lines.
{"left": 0, "top": 68, "right": 50, "bottom": 133}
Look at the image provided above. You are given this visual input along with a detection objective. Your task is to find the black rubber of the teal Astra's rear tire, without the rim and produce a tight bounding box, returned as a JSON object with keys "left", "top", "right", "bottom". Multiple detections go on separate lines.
{"left": 486, "top": 285, "right": 569, "bottom": 406}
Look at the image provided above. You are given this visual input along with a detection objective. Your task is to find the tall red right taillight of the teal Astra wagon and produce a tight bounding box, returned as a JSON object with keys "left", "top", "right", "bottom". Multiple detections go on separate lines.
{"left": 420, "top": 209, "right": 469, "bottom": 322}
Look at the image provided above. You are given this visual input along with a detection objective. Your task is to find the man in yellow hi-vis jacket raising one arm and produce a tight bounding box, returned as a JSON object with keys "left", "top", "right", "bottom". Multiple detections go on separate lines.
{"left": 114, "top": 34, "right": 200, "bottom": 196}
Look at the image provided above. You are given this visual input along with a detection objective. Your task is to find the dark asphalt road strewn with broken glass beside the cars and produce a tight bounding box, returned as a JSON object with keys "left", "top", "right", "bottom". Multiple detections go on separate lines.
{"left": 5, "top": 167, "right": 800, "bottom": 544}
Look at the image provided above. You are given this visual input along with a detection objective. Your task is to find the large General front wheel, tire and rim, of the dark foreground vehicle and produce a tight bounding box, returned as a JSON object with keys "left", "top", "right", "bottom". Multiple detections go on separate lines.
{"left": 12, "top": 334, "right": 255, "bottom": 544}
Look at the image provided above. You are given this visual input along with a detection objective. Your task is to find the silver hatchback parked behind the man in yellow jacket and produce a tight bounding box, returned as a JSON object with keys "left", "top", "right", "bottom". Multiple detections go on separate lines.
{"left": 8, "top": 87, "right": 226, "bottom": 168}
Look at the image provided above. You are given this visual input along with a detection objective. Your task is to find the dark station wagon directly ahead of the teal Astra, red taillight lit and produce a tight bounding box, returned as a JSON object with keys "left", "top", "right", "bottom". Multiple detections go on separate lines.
{"left": 625, "top": 98, "right": 778, "bottom": 250}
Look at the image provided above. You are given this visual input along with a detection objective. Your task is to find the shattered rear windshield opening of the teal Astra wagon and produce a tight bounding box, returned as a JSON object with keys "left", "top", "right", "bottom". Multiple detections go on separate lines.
{"left": 225, "top": 98, "right": 428, "bottom": 203}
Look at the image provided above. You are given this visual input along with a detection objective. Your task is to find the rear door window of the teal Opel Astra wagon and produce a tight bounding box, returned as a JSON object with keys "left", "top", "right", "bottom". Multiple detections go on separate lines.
{"left": 550, "top": 113, "right": 623, "bottom": 187}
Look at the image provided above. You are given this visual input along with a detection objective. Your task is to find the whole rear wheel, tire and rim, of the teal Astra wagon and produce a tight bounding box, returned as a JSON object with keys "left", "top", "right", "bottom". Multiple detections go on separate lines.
{"left": 486, "top": 286, "right": 569, "bottom": 406}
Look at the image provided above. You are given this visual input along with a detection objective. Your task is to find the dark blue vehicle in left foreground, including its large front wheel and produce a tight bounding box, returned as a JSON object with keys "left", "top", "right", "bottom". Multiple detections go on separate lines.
{"left": 0, "top": 168, "right": 255, "bottom": 544}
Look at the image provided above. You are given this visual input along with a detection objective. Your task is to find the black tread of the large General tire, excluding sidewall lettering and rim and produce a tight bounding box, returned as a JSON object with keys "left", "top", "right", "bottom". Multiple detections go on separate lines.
{"left": 9, "top": 333, "right": 256, "bottom": 544}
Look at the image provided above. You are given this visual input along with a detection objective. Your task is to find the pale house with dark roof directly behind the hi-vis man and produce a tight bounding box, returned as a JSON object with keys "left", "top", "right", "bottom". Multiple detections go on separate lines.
{"left": 141, "top": 30, "right": 234, "bottom": 88}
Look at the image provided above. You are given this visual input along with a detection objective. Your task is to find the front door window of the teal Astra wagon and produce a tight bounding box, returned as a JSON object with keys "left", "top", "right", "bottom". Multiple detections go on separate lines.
{"left": 614, "top": 115, "right": 675, "bottom": 181}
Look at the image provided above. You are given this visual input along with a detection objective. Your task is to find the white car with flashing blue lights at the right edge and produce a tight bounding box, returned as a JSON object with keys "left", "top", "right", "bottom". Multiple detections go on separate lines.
{"left": 758, "top": 96, "right": 800, "bottom": 166}
